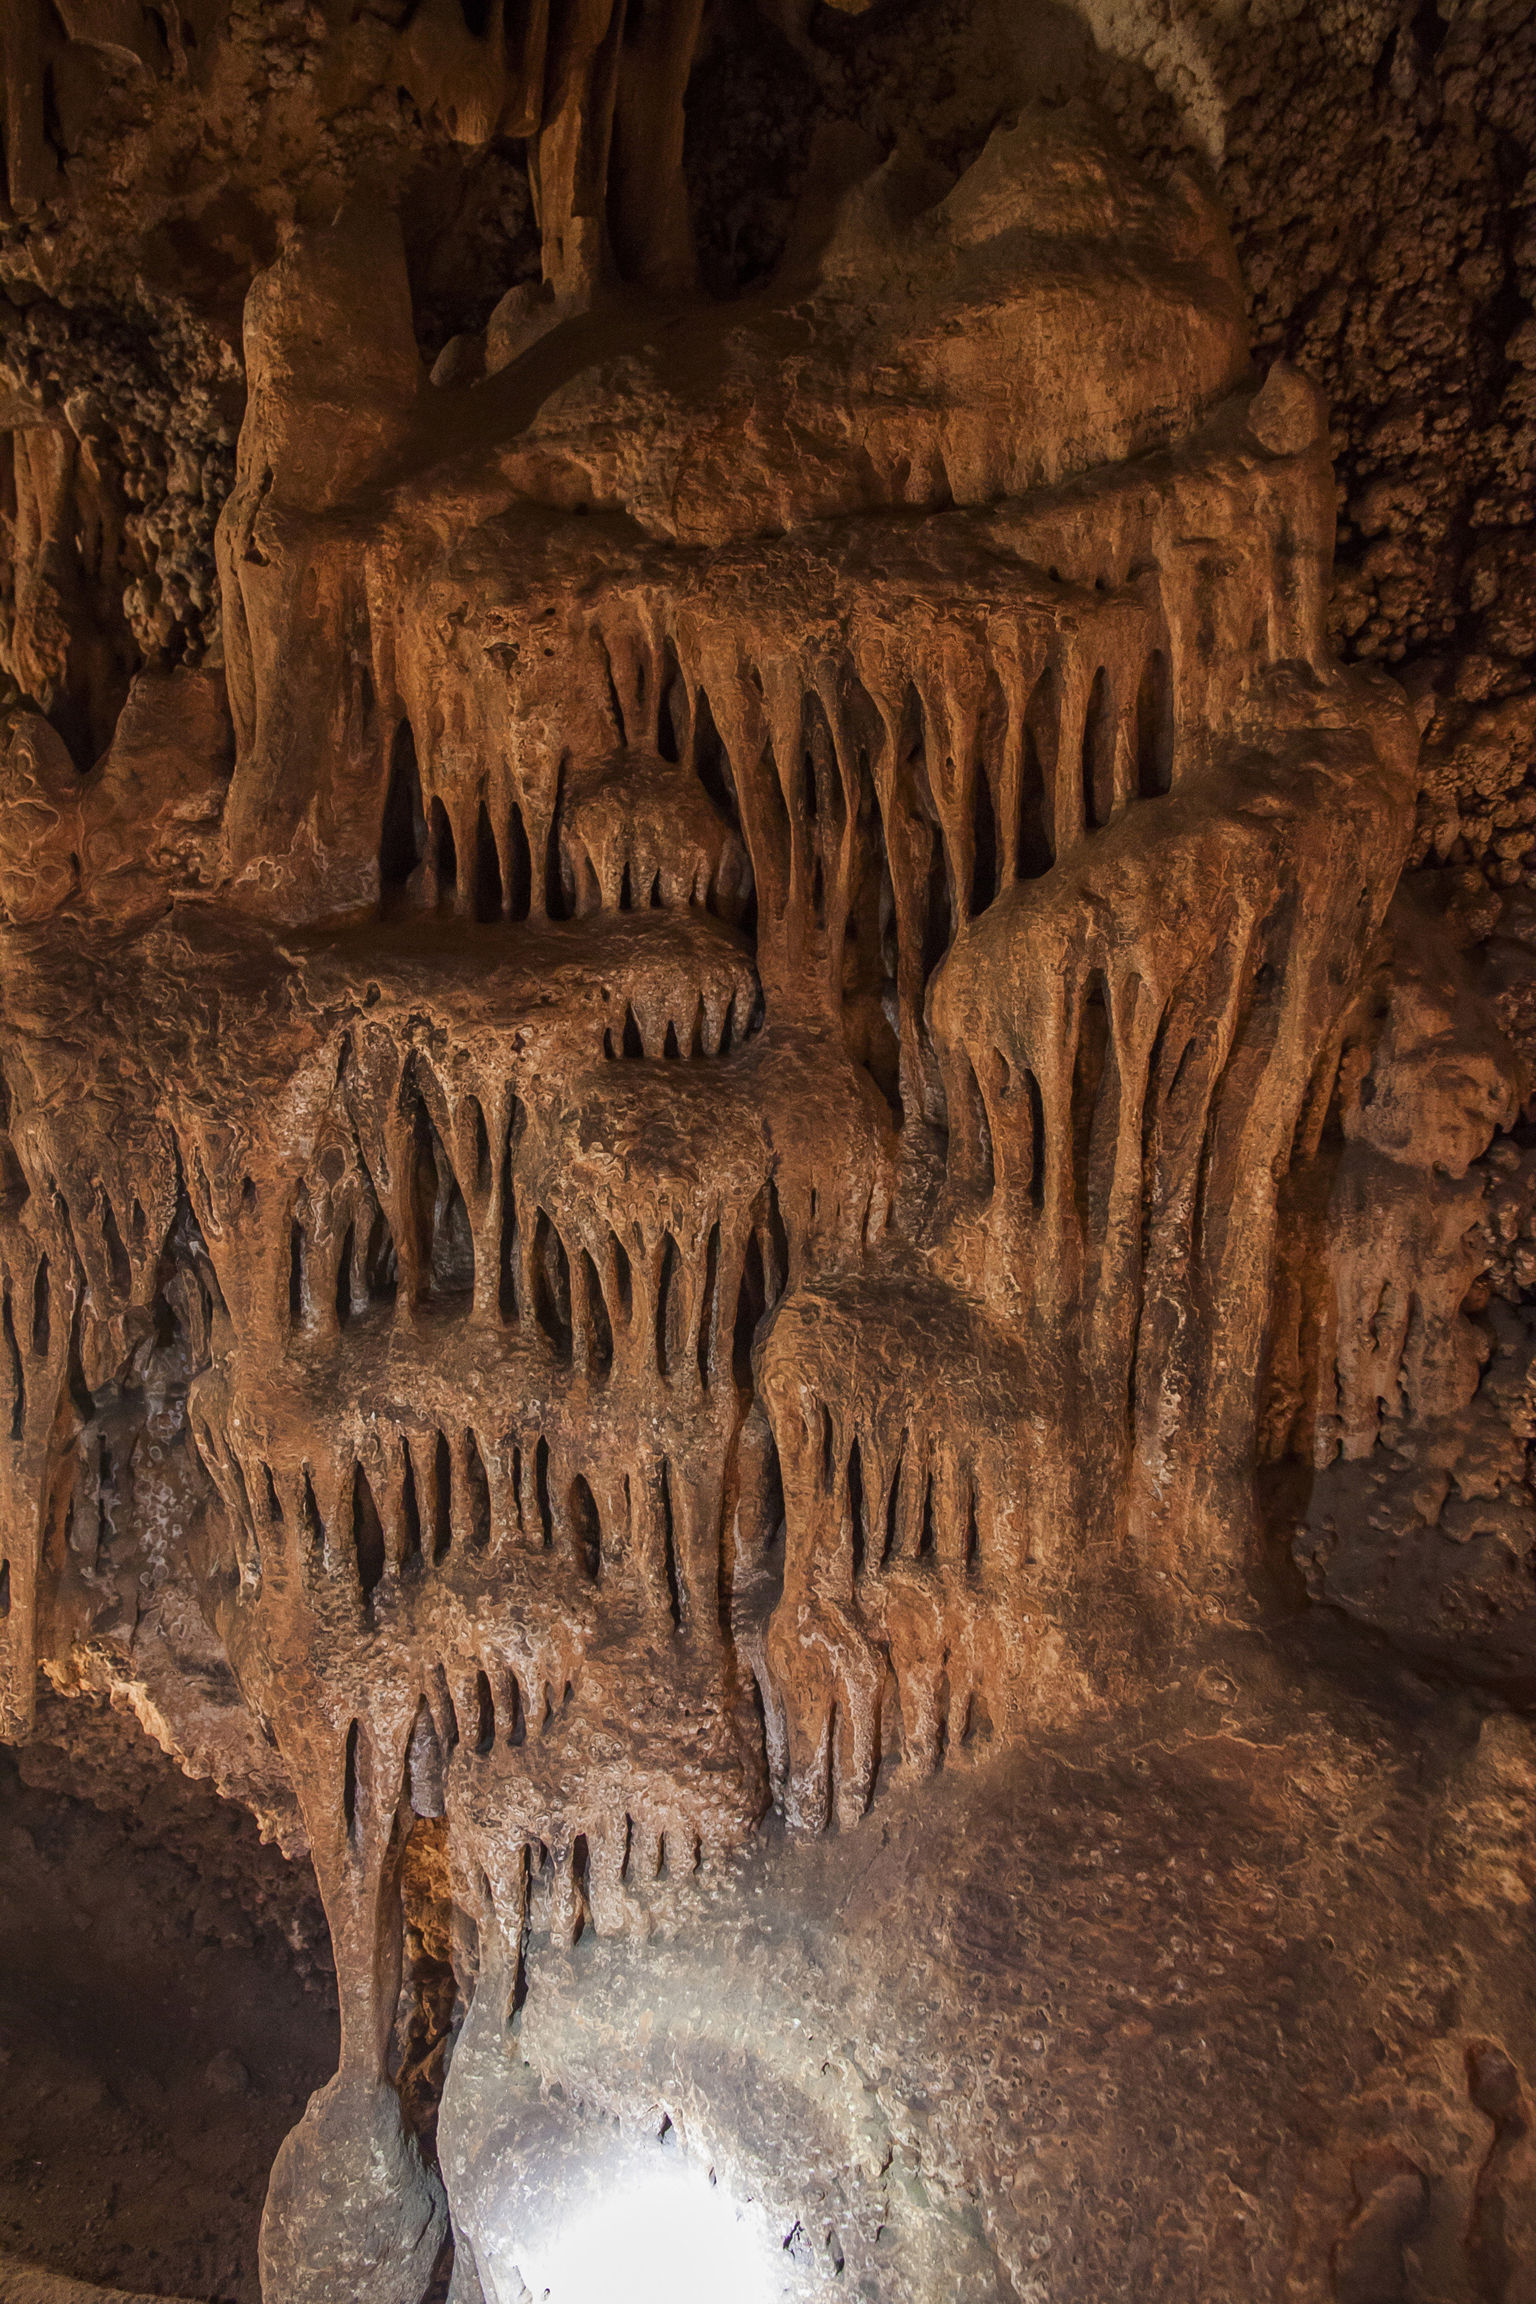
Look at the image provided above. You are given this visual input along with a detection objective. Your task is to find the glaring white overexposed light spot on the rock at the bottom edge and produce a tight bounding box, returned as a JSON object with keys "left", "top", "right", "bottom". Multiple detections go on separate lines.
{"left": 518, "top": 2163, "right": 778, "bottom": 2304}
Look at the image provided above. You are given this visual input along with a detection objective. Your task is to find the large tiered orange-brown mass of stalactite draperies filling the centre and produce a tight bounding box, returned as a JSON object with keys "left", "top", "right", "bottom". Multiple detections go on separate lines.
{"left": 0, "top": 116, "right": 1464, "bottom": 2294}
